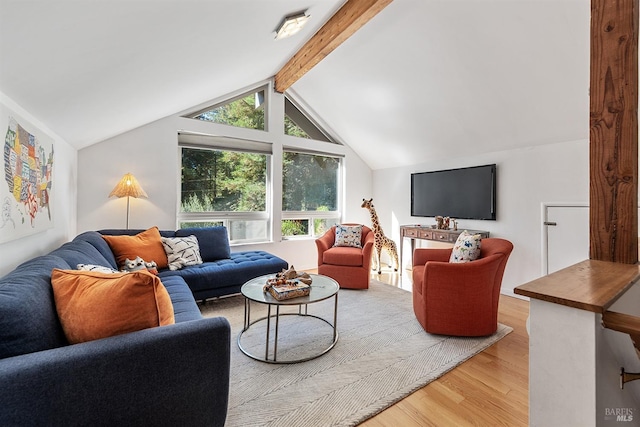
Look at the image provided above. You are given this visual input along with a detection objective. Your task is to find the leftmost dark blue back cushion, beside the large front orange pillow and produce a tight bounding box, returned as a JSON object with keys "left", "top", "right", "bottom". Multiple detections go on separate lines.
{"left": 0, "top": 255, "right": 69, "bottom": 359}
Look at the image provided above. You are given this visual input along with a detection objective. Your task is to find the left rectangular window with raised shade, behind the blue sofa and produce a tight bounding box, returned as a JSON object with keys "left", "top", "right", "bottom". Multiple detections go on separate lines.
{"left": 178, "top": 134, "right": 271, "bottom": 243}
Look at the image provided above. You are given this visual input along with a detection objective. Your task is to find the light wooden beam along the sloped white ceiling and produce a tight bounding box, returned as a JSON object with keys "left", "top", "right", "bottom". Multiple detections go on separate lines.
{"left": 275, "top": 0, "right": 393, "bottom": 93}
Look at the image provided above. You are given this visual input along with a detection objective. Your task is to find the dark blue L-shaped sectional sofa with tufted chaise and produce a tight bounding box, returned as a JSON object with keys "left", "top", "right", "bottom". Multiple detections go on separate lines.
{"left": 0, "top": 226, "right": 282, "bottom": 426}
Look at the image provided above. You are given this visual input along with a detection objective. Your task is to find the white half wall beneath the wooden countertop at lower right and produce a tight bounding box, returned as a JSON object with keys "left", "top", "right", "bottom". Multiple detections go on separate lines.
{"left": 529, "top": 283, "right": 640, "bottom": 427}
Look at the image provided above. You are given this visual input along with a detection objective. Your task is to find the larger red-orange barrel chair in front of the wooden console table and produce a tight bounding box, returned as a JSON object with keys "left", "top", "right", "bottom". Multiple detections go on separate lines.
{"left": 413, "top": 238, "right": 513, "bottom": 337}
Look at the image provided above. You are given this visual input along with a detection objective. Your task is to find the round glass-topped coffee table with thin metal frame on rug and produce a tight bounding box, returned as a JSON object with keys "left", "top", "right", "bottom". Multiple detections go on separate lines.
{"left": 238, "top": 274, "right": 340, "bottom": 363}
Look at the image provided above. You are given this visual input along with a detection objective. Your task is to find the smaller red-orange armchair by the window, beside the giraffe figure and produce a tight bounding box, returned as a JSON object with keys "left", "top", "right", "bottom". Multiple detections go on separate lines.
{"left": 316, "top": 224, "right": 373, "bottom": 289}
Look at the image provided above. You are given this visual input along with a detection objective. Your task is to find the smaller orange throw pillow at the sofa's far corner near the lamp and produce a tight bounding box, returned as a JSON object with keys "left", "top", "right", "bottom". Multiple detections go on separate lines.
{"left": 102, "top": 227, "right": 169, "bottom": 268}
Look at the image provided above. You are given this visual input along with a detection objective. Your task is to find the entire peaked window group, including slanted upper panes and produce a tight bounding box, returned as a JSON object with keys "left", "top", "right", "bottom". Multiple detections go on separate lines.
{"left": 177, "top": 84, "right": 343, "bottom": 244}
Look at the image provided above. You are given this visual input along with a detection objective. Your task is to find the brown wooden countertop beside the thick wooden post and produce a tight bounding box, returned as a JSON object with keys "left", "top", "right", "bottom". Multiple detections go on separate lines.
{"left": 514, "top": 260, "right": 640, "bottom": 313}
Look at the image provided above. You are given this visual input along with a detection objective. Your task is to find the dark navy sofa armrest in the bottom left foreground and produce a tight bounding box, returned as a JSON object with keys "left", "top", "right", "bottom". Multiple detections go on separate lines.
{"left": 0, "top": 317, "right": 231, "bottom": 426}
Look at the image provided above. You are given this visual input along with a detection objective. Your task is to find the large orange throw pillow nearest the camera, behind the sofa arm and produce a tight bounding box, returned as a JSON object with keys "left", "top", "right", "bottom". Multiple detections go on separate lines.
{"left": 51, "top": 268, "right": 175, "bottom": 344}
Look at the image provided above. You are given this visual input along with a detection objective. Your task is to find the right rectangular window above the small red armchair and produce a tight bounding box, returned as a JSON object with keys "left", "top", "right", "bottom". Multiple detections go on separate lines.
{"left": 282, "top": 151, "right": 341, "bottom": 238}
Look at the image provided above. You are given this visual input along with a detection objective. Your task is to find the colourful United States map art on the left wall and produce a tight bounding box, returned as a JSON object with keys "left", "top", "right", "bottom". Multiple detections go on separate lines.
{"left": 0, "top": 105, "right": 54, "bottom": 243}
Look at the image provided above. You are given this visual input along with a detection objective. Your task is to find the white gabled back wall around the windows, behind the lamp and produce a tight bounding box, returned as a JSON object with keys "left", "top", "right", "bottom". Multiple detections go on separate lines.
{"left": 78, "top": 82, "right": 372, "bottom": 269}
